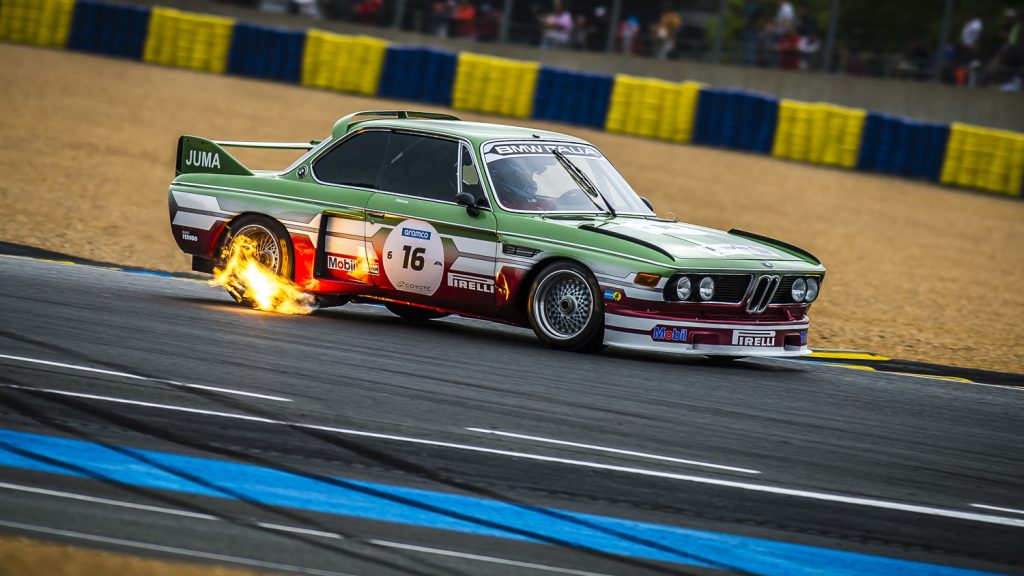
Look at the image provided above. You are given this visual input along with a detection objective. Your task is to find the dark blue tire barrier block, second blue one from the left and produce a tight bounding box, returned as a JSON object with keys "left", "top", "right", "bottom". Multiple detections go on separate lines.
{"left": 227, "top": 22, "right": 306, "bottom": 84}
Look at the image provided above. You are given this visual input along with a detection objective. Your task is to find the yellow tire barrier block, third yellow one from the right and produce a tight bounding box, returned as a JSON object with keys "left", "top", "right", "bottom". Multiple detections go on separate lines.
{"left": 604, "top": 74, "right": 700, "bottom": 142}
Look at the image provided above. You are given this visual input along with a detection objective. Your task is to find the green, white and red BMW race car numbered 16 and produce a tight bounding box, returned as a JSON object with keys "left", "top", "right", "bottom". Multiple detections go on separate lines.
{"left": 169, "top": 111, "right": 825, "bottom": 357}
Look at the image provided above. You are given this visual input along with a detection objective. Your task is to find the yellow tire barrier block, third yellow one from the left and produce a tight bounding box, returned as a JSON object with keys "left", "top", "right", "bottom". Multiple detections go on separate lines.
{"left": 302, "top": 29, "right": 388, "bottom": 96}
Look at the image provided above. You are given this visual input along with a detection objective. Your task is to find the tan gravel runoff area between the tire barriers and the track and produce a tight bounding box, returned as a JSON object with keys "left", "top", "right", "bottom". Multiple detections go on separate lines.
{"left": 0, "top": 44, "right": 1024, "bottom": 372}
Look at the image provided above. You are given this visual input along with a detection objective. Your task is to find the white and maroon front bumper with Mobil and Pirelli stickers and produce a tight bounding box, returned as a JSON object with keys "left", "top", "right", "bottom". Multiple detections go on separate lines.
{"left": 604, "top": 313, "right": 811, "bottom": 358}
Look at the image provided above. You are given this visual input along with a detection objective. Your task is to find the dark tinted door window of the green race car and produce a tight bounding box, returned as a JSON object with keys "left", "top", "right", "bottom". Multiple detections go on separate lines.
{"left": 380, "top": 133, "right": 459, "bottom": 202}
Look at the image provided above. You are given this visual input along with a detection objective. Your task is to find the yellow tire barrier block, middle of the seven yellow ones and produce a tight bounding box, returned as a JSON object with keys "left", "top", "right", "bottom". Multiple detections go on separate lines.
{"left": 452, "top": 52, "right": 541, "bottom": 118}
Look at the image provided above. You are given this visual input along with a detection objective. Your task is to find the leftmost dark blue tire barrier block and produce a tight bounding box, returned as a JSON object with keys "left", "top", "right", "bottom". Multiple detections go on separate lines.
{"left": 68, "top": 0, "right": 150, "bottom": 60}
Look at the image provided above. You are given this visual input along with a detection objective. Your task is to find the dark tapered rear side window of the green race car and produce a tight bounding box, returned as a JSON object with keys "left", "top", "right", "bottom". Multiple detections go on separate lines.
{"left": 313, "top": 130, "right": 388, "bottom": 189}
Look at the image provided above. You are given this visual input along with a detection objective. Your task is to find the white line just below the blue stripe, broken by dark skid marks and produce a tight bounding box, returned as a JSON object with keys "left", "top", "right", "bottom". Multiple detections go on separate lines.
{"left": 0, "top": 482, "right": 607, "bottom": 576}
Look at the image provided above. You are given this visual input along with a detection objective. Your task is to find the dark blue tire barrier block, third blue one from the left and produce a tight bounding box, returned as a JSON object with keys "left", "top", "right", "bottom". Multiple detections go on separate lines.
{"left": 377, "top": 46, "right": 458, "bottom": 106}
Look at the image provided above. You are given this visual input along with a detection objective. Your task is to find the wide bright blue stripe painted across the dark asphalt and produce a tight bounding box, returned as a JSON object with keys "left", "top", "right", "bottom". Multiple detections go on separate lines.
{"left": 0, "top": 430, "right": 995, "bottom": 576}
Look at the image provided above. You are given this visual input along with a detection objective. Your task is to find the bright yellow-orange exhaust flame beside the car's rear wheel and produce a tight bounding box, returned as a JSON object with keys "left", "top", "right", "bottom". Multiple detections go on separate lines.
{"left": 210, "top": 236, "right": 316, "bottom": 314}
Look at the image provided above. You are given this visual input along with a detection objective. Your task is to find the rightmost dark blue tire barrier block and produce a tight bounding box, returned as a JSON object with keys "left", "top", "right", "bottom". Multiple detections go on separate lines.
{"left": 857, "top": 112, "right": 949, "bottom": 181}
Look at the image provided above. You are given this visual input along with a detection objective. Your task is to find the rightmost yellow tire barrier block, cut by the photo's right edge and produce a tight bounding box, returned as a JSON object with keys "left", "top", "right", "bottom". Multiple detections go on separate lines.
{"left": 941, "top": 122, "right": 1024, "bottom": 196}
